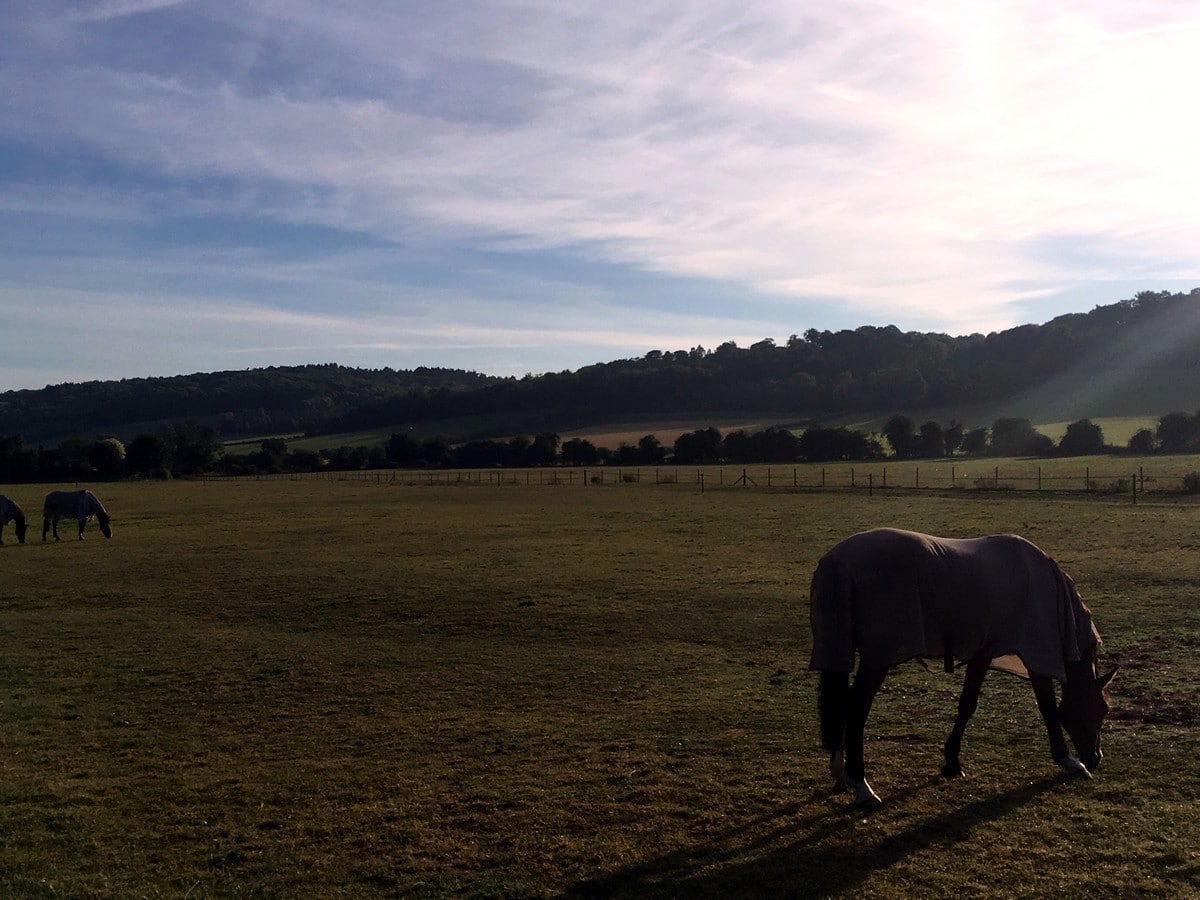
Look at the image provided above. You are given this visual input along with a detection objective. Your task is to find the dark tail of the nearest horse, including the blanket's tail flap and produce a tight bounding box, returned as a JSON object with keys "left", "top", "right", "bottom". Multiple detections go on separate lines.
{"left": 809, "top": 556, "right": 854, "bottom": 752}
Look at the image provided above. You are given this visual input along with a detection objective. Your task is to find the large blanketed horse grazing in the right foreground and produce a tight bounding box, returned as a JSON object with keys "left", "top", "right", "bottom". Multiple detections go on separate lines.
{"left": 809, "top": 528, "right": 1116, "bottom": 806}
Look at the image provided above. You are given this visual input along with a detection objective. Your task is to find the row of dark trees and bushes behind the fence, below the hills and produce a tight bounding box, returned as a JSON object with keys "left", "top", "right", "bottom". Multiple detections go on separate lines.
{"left": 7, "top": 412, "right": 1200, "bottom": 484}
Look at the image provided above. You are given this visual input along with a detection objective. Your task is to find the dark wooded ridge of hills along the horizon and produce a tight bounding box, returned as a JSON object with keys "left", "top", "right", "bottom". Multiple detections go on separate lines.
{"left": 0, "top": 288, "right": 1200, "bottom": 443}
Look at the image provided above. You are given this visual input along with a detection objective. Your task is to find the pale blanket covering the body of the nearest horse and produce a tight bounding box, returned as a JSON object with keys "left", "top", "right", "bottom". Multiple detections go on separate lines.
{"left": 810, "top": 528, "right": 1099, "bottom": 682}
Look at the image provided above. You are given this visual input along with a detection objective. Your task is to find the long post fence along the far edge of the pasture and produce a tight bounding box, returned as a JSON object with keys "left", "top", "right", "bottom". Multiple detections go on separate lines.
{"left": 211, "top": 462, "right": 1200, "bottom": 500}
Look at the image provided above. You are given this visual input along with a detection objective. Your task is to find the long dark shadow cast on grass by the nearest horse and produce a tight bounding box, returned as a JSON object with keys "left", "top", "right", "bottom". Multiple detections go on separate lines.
{"left": 564, "top": 775, "right": 1066, "bottom": 900}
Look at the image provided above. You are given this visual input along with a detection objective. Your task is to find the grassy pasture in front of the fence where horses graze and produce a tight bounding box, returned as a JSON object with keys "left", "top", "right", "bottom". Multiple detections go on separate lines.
{"left": 0, "top": 480, "right": 1200, "bottom": 898}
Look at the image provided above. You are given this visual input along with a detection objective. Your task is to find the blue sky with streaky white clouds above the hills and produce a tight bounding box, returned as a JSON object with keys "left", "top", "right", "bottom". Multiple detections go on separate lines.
{"left": 0, "top": 0, "right": 1200, "bottom": 391}
